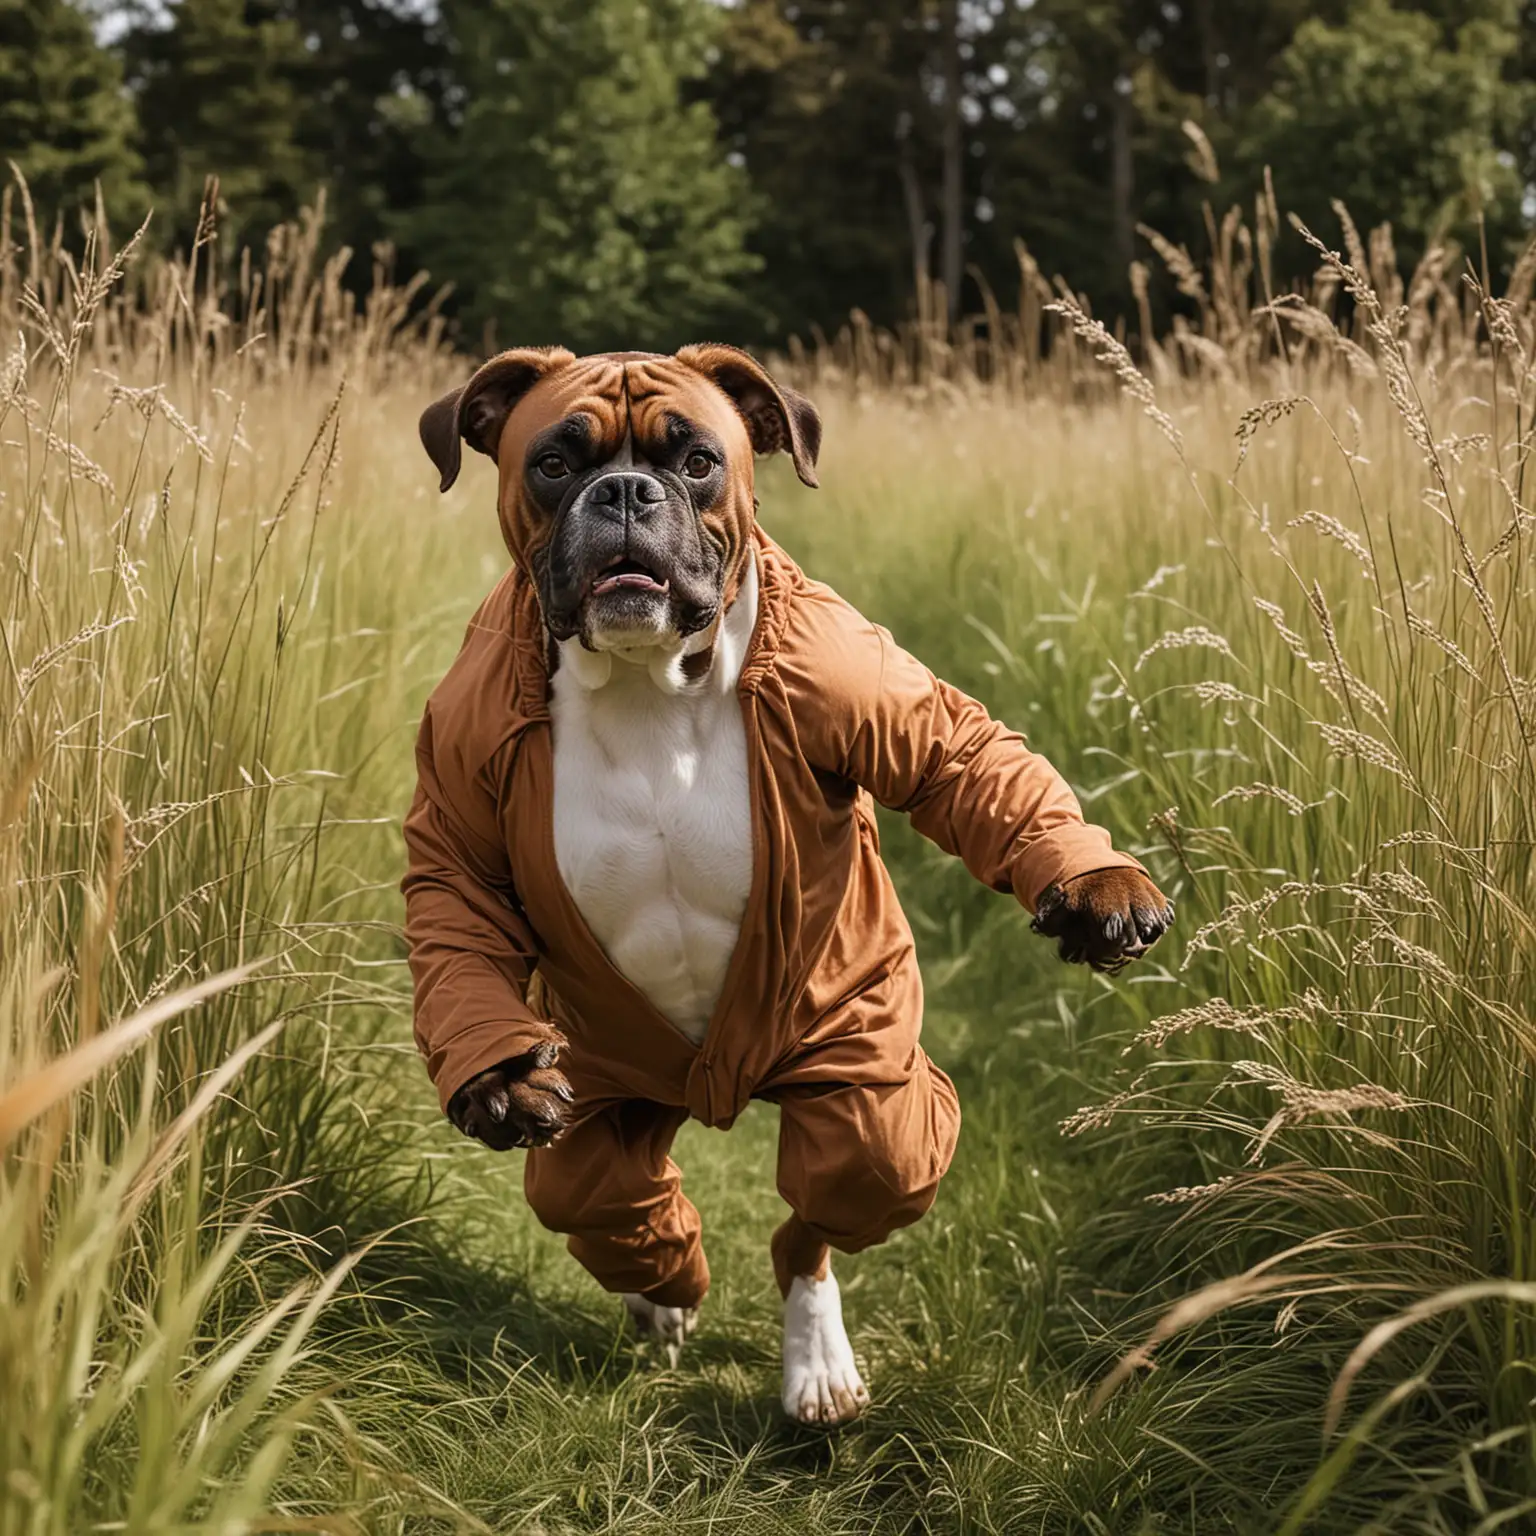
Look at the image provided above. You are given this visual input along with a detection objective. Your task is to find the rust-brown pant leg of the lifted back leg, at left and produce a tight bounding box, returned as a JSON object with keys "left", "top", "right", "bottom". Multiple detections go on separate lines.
{"left": 524, "top": 1100, "right": 710, "bottom": 1307}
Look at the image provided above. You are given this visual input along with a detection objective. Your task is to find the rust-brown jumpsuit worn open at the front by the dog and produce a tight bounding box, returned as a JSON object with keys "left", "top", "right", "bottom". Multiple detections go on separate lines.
{"left": 404, "top": 530, "right": 1140, "bottom": 1306}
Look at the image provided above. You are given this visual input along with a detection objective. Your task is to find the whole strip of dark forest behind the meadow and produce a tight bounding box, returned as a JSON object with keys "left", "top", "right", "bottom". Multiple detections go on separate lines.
{"left": 0, "top": 0, "right": 1536, "bottom": 347}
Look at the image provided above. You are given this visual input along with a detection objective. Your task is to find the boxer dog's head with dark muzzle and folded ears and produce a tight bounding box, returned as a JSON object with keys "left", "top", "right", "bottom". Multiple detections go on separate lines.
{"left": 421, "top": 343, "right": 822, "bottom": 653}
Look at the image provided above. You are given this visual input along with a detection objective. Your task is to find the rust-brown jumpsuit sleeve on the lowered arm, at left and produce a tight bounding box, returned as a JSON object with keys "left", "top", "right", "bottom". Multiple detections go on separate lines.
{"left": 401, "top": 705, "right": 561, "bottom": 1109}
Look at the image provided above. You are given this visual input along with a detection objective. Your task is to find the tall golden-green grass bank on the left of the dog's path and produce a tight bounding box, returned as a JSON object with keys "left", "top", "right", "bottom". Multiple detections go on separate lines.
{"left": 0, "top": 194, "right": 482, "bottom": 1533}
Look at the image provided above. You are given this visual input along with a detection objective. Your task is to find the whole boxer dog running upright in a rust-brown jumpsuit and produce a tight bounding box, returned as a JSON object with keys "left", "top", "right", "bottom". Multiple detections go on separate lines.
{"left": 404, "top": 344, "right": 1174, "bottom": 1424}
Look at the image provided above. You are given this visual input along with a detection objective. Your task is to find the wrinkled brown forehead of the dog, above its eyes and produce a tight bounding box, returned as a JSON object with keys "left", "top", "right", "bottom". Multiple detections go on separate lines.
{"left": 496, "top": 352, "right": 753, "bottom": 479}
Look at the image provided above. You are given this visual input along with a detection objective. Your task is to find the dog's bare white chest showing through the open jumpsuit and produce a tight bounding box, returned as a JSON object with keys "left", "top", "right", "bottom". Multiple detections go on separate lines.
{"left": 550, "top": 568, "right": 757, "bottom": 1041}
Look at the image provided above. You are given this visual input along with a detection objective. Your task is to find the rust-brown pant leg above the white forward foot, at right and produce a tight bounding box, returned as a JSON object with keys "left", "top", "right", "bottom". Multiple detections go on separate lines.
{"left": 773, "top": 1049, "right": 960, "bottom": 1295}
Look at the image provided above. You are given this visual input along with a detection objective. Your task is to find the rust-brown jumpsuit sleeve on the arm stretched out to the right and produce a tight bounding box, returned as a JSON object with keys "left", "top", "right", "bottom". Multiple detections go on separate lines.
{"left": 819, "top": 599, "right": 1141, "bottom": 911}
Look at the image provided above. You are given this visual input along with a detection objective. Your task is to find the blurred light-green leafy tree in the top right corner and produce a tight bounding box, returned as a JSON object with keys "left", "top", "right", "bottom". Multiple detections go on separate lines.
{"left": 1243, "top": 0, "right": 1536, "bottom": 255}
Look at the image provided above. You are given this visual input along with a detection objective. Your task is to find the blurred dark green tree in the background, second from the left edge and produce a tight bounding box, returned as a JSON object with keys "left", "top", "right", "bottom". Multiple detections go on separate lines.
{"left": 124, "top": 0, "right": 318, "bottom": 247}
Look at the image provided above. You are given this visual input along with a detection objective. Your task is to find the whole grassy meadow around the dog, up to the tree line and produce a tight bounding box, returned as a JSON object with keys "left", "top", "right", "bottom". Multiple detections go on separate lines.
{"left": 0, "top": 200, "right": 1536, "bottom": 1536}
